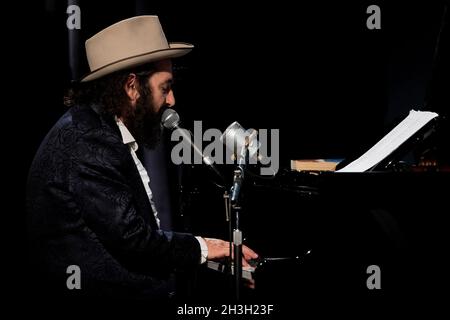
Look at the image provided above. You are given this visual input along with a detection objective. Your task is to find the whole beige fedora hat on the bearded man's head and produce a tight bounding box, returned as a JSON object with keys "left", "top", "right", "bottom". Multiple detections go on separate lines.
{"left": 81, "top": 16, "right": 194, "bottom": 82}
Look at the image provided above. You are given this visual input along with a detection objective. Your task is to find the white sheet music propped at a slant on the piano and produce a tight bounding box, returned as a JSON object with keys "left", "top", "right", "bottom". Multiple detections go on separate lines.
{"left": 336, "top": 110, "right": 438, "bottom": 172}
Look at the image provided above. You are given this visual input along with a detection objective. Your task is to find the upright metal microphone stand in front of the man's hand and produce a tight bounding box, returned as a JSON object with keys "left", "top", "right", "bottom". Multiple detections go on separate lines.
{"left": 230, "top": 146, "right": 248, "bottom": 301}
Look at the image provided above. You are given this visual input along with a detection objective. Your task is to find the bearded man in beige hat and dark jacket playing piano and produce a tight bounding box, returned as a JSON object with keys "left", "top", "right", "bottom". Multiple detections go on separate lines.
{"left": 27, "top": 16, "right": 257, "bottom": 298}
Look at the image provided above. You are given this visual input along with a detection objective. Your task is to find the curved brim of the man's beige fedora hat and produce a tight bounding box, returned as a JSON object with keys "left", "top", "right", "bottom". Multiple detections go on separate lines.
{"left": 80, "top": 42, "right": 194, "bottom": 82}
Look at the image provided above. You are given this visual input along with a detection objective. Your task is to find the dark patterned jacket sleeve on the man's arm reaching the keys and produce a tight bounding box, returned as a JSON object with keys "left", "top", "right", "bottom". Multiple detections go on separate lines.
{"left": 70, "top": 130, "right": 200, "bottom": 272}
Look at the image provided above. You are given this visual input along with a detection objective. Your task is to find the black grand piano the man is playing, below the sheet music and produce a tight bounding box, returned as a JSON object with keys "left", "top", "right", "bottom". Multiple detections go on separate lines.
{"left": 171, "top": 109, "right": 450, "bottom": 311}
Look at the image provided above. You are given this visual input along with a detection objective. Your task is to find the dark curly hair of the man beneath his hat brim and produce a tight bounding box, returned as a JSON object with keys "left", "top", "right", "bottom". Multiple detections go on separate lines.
{"left": 64, "top": 64, "right": 155, "bottom": 117}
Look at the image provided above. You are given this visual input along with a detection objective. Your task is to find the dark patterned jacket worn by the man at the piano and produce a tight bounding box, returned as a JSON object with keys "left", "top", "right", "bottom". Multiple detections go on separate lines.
{"left": 27, "top": 106, "right": 200, "bottom": 298}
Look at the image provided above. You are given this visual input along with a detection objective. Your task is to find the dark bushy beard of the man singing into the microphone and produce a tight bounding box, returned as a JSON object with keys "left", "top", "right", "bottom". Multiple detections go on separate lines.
{"left": 125, "top": 92, "right": 167, "bottom": 149}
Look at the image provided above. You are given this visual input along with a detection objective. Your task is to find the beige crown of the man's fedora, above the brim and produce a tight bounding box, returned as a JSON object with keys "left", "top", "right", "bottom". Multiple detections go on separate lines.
{"left": 85, "top": 16, "right": 169, "bottom": 71}
